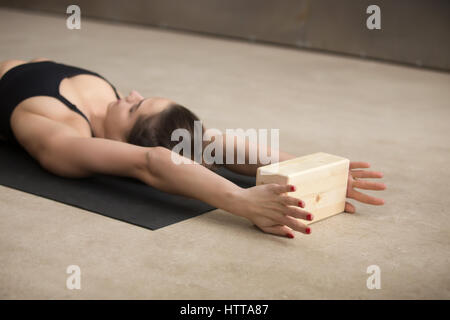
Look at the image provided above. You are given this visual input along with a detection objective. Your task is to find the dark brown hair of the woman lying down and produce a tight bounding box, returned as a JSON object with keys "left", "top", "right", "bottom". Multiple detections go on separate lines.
{"left": 128, "top": 104, "right": 217, "bottom": 171}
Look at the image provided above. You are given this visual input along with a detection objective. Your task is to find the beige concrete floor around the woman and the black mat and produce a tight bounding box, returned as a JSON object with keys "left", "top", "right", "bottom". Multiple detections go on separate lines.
{"left": 0, "top": 8, "right": 450, "bottom": 299}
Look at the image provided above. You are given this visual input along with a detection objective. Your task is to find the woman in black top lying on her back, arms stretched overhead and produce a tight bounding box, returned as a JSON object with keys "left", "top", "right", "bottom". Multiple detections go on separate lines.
{"left": 0, "top": 58, "right": 386, "bottom": 238}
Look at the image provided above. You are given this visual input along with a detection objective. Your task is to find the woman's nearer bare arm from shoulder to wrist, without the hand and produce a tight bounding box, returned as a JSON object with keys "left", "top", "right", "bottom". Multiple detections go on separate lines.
{"left": 13, "top": 112, "right": 244, "bottom": 209}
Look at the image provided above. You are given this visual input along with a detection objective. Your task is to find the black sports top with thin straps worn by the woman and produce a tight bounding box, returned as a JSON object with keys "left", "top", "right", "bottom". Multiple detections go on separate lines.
{"left": 0, "top": 61, "right": 120, "bottom": 142}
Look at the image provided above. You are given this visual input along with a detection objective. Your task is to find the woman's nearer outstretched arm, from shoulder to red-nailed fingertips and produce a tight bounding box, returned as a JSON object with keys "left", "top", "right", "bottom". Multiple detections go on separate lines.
{"left": 13, "top": 113, "right": 308, "bottom": 237}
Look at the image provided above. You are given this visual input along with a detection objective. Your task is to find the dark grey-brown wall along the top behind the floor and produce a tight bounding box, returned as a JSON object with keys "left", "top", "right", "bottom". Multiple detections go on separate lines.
{"left": 0, "top": 0, "right": 450, "bottom": 71}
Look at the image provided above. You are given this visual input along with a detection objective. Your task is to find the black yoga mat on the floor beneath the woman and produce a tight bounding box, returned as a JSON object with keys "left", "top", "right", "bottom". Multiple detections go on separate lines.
{"left": 0, "top": 142, "right": 256, "bottom": 230}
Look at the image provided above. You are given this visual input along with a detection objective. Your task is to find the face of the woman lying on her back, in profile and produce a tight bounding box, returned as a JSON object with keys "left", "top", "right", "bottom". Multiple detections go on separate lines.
{"left": 105, "top": 90, "right": 175, "bottom": 141}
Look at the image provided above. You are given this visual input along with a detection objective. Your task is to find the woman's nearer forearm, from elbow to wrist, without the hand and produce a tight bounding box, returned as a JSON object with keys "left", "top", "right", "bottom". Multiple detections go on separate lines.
{"left": 138, "top": 147, "right": 242, "bottom": 213}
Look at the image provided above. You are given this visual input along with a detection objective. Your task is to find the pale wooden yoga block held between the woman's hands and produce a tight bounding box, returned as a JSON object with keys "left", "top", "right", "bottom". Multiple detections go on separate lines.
{"left": 256, "top": 152, "right": 350, "bottom": 224}
